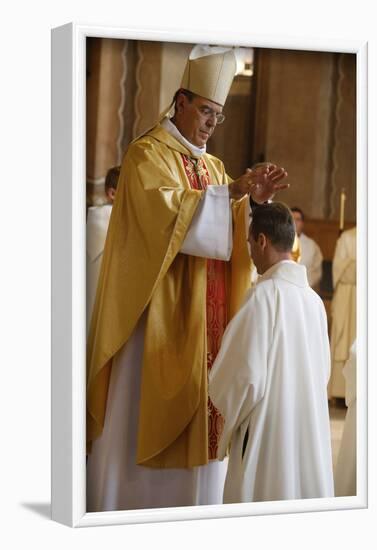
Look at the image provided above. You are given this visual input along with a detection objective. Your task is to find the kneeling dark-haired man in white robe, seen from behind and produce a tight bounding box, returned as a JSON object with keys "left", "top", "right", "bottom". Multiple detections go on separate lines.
{"left": 209, "top": 203, "right": 334, "bottom": 503}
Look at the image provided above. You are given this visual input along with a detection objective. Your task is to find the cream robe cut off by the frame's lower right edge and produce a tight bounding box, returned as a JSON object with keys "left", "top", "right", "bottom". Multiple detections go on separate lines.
{"left": 335, "top": 340, "right": 357, "bottom": 497}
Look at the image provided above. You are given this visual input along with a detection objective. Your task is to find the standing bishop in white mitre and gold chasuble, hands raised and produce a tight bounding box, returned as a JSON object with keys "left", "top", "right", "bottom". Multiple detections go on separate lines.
{"left": 87, "top": 47, "right": 287, "bottom": 511}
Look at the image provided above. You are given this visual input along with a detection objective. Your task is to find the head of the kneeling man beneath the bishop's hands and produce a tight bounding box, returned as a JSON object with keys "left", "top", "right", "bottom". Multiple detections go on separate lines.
{"left": 248, "top": 202, "right": 295, "bottom": 275}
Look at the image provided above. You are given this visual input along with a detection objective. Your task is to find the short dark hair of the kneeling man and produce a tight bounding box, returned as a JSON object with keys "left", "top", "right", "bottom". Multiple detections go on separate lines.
{"left": 250, "top": 202, "right": 296, "bottom": 252}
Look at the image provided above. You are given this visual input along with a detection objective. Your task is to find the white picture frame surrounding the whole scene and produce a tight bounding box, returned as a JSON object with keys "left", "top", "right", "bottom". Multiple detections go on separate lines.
{"left": 52, "top": 23, "right": 368, "bottom": 527}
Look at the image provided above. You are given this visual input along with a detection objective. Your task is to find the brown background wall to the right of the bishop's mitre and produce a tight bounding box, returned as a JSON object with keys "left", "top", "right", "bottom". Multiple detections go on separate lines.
{"left": 253, "top": 50, "right": 356, "bottom": 222}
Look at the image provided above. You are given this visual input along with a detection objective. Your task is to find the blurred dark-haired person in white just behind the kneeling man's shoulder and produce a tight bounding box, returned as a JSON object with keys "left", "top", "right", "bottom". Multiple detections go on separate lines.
{"left": 291, "top": 206, "right": 323, "bottom": 291}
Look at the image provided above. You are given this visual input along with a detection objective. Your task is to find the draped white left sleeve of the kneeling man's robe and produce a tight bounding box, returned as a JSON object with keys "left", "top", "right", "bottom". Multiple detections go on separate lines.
{"left": 209, "top": 281, "right": 274, "bottom": 458}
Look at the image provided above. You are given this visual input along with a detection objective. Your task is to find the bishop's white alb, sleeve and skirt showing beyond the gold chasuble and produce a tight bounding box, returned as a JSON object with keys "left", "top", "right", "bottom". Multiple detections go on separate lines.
{"left": 87, "top": 185, "right": 233, "bottom": 512}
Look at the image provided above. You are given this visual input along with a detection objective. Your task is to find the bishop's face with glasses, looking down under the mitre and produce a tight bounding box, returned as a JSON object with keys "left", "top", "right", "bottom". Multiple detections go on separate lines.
{"left": 175, "top": 94, "right": 223, "bottom": 147}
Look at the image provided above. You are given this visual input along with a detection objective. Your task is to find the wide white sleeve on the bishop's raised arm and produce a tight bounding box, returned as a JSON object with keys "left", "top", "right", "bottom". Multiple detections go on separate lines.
{"left": 180, "top": 185, "right": 232, "bottom": 260}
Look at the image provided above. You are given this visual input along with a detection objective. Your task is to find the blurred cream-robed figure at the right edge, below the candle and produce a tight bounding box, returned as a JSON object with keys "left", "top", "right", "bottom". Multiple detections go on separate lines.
{"left": 329, "top": 227, "right": 356, "bottom": 397}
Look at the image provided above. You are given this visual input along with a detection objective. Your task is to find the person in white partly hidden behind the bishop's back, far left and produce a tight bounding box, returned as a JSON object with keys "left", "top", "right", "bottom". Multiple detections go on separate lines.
{"left": 86, "top": 166, "right": 120, "bottom": 327}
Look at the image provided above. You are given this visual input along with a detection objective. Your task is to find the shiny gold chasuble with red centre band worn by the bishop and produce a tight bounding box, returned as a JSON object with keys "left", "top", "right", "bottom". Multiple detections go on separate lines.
{"left": 87, "top": 125, "right": 251, "bottom": 468}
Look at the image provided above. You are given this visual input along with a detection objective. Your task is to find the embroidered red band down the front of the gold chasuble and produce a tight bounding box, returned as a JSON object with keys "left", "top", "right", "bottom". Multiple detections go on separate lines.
{"left": 182, "top": 155, "right": 227, "bottom": 460}
